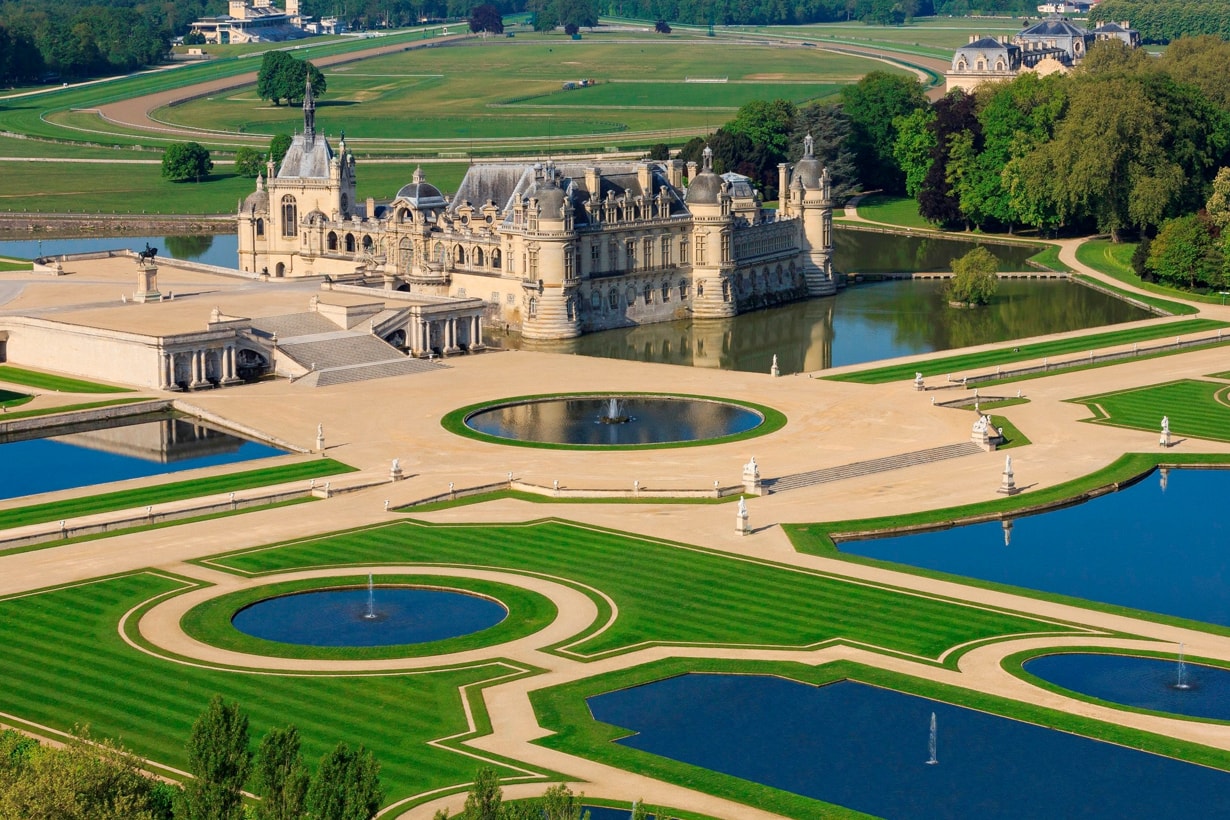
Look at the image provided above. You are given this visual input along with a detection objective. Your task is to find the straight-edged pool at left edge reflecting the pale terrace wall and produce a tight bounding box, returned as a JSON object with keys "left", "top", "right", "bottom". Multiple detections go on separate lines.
{"left": 0, "top": 416, "right": 284, "bottom": 498}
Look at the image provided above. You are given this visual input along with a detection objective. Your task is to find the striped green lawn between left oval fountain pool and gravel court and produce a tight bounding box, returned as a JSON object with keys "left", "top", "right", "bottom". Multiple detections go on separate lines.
{"left": 210, "top": 521, "right": 1077, "bottom": 658}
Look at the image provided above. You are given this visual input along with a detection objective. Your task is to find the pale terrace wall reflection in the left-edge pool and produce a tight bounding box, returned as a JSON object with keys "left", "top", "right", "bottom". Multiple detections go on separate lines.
{"left": 40, "top": 418, "right": 257, "bottom": 463}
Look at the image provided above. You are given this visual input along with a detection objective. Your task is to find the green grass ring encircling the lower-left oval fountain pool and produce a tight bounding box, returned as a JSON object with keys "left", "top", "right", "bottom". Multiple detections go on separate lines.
{"left": 180, "top": 575, "right": 558, "bottom": 660}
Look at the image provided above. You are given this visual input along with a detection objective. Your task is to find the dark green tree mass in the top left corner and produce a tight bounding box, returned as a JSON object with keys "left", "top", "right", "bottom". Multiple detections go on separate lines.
{"left": 0, "top": 0, "right": 189, "bottom": 85}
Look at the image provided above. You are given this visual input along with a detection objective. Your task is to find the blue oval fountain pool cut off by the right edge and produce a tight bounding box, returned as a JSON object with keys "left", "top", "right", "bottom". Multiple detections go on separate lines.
{"left": 1023, "top": 652, "right": 1230, "bottom": 720}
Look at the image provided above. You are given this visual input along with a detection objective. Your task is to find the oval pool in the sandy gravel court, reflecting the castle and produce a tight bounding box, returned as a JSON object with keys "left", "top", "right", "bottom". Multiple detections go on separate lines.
{"left": 465, "top": 395, "right": 764, "bottom": 446}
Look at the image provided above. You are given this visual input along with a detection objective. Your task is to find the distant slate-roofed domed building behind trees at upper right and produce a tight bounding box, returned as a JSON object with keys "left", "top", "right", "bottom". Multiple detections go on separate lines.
{"left": 945, "top": 17, "right": 1140, "bottom": 91}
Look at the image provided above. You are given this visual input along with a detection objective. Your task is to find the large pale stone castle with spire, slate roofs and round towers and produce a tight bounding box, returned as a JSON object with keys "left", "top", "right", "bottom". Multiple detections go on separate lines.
{"left": 239, "top": 87, "right": 835, "bottom": 353}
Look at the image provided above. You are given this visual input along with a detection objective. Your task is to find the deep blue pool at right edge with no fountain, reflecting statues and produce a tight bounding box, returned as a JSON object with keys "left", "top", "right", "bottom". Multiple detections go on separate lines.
{"left": 838, "top": 472, "right": 1230, "bottom": 626}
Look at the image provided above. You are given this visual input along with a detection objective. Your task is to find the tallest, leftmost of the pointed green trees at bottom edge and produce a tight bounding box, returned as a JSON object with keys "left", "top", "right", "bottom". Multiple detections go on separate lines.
{"left": 176, "top": 695, "right": 252, "bottom": 820}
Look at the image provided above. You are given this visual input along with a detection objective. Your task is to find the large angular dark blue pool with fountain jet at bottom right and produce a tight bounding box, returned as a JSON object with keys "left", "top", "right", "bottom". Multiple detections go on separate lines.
{"left": 589, "top": 674, "right": 1230, "bottom": 820}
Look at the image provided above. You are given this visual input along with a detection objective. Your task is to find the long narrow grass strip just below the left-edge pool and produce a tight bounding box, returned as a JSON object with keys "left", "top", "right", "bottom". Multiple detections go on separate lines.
{"left": 0, "top": 459, "right": 354, "bottom": 530}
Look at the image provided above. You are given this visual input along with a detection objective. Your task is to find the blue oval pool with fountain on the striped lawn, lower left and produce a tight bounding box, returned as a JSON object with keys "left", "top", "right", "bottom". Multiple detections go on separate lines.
{"left": 231, "top": 586, "right": 508, "bottom": 647}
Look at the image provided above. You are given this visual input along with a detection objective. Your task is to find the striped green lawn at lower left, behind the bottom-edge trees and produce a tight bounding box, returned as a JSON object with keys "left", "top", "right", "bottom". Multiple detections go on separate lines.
{"left": 0, "top": 573, "right": 538, "bottom": 802}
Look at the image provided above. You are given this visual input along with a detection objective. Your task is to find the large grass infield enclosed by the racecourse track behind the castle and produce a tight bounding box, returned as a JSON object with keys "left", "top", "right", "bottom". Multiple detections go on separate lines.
{"left": 155, "top": 32, "right": 900, "bottom": 142}
